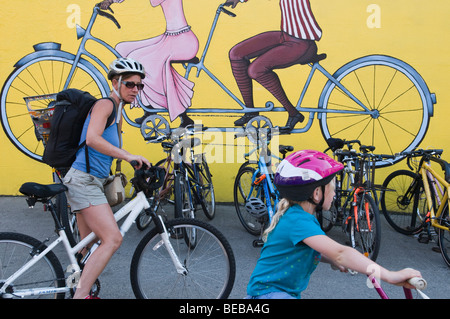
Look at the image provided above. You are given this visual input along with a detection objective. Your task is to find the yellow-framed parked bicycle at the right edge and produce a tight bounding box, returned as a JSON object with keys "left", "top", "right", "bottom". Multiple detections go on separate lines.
{"left": 381, "top": 149, "right": 450, "bottom": 267}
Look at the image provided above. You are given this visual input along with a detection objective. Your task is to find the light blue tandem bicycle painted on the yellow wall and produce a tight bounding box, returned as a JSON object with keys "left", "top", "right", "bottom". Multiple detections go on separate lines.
{"left": 0, "top": 4, "right": 436, "bottom": 166}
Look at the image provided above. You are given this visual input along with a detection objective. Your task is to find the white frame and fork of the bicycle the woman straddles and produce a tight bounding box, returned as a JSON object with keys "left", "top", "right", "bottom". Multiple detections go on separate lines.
{"left": 0, "top": 191, "right": 187, "bottom": 298}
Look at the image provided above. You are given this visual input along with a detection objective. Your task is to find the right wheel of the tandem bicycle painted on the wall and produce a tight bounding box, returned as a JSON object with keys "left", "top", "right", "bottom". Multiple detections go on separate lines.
{"left": 318, "top": 55, "right": 435, "bottom": 167}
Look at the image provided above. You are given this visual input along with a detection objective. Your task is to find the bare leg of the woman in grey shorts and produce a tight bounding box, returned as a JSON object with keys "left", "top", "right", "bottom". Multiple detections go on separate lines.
{"left": 74, "top": 204, "right": 122, "bottom": 299}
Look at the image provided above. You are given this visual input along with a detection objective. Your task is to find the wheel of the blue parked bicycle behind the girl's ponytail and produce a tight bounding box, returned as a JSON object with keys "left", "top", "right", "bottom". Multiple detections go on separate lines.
{"left": 233, "top": 166, "right": 269, "bottom": 236}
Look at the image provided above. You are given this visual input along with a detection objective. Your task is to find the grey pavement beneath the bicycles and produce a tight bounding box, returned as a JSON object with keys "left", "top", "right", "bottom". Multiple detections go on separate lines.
{"left": 0, "top": 197, "right": 450, "bottom": 302}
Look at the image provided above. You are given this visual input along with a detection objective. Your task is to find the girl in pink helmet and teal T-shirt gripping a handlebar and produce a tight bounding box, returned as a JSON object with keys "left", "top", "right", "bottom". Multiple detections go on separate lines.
{"left": 247, "top": 150, "right": 421, "bottom": 299}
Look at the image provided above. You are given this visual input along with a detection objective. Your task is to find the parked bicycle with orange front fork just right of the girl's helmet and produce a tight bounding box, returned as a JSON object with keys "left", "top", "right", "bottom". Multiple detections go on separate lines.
{"left": 317, "top": 139, "right": 395, "bottom": 261}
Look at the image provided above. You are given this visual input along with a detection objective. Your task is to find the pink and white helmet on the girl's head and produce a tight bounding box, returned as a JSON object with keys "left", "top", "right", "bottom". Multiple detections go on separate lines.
{"left": 274, "top": 150, "right": 344, "bottom": 201}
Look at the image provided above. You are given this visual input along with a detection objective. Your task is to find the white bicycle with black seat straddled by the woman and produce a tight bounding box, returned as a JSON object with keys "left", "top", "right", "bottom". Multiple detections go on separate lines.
{"left": 0, "top": 162, "right": 236, "bottom": 299}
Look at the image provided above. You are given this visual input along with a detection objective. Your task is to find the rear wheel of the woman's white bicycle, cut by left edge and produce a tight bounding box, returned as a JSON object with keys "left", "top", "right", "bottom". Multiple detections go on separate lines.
{"left": 0, "top": 233, "right": 65, "bottom": 299}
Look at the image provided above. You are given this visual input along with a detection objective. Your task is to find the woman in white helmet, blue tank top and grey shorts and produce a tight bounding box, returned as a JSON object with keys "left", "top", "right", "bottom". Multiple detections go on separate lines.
{"left": 64, "top": 58, "right": 150, "bottom": 299}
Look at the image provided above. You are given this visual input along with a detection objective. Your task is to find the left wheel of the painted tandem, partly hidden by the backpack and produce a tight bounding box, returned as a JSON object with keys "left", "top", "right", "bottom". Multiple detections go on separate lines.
{"left": 0, "top": 51, "right": 108, "bottom": 161}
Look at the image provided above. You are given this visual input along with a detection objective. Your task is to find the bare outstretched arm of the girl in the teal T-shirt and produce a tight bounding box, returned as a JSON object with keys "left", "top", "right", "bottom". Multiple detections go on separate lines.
{"left": 303, "top": 235, "right": 421, "bottom": 288}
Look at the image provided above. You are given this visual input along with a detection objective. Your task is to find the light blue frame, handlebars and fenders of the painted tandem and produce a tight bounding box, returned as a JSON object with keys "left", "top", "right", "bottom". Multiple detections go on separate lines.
{"left": 1, "top": 4, "right": 436, "bottom": 166}
